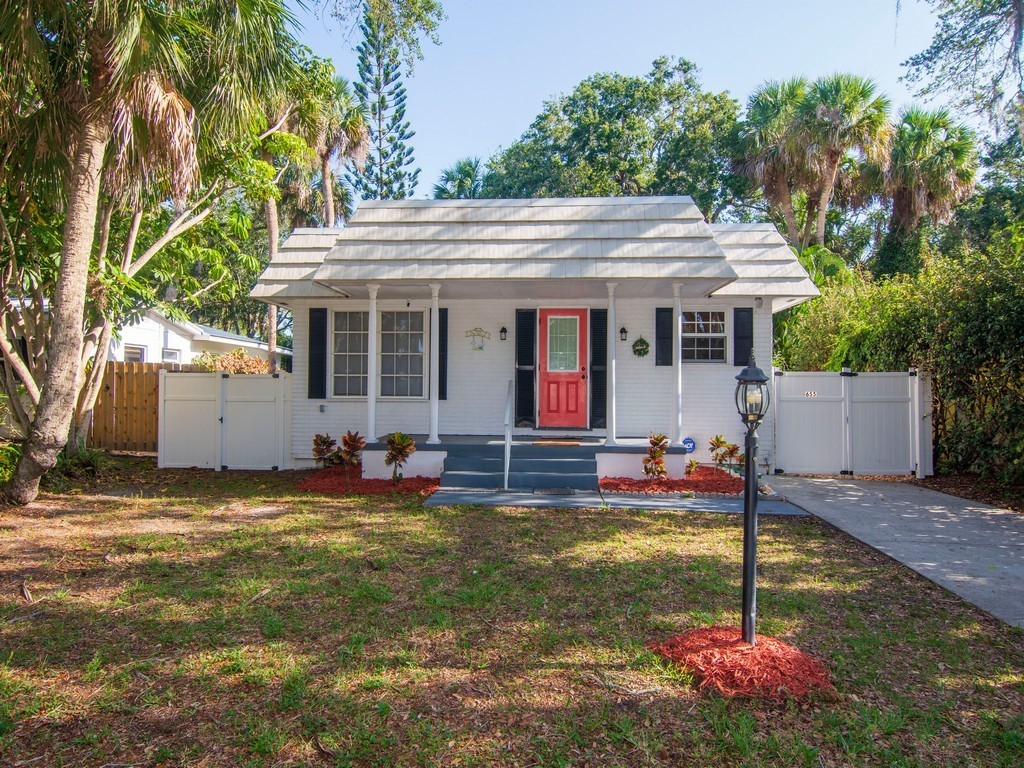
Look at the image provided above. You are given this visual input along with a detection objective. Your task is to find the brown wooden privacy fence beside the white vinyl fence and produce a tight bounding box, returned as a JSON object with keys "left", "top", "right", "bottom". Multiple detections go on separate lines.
{"left": 89, "top": 361, "right": 205, "bottom": 453}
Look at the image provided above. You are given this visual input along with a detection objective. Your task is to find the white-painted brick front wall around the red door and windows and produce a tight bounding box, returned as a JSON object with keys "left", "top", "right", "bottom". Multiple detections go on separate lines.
{"left": 291, "top": 291, "right": 772, "bottom": 461}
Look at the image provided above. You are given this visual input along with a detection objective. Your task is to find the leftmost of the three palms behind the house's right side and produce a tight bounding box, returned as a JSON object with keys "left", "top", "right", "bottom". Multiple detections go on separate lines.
{"left": 737, "top": 77, "right": 810, "bottom": 247}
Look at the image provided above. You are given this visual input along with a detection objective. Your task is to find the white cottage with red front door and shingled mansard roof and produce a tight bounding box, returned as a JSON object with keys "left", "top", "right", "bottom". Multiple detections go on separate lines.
{"left": 252, "top": 197, "right": 818, "bottom": 486}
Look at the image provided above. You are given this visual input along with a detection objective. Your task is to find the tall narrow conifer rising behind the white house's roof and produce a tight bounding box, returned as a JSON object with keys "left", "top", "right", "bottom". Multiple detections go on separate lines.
{"left": 348, "top": 3, "right": 420, "bottom": 200}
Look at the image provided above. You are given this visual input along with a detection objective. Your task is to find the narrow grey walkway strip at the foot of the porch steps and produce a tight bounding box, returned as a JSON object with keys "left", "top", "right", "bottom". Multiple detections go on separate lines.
{"left": 423, "top": 488, "right": 807, "bottom": 517}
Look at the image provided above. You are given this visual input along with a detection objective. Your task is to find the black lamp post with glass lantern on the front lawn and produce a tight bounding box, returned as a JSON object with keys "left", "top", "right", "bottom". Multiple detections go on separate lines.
{"left": 736, "top": 350, "right": 771, "bottom": 645}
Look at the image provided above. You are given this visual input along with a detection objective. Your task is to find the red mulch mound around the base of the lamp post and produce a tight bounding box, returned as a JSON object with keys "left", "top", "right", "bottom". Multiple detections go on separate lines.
{"left": 647, "top": 627, "right": 834, "bottom": 700}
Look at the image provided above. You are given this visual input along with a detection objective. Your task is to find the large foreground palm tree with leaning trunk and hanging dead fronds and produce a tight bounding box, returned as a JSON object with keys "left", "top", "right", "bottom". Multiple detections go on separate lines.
{"left": 0, "top": 0, "right": 292, "bottom": 504}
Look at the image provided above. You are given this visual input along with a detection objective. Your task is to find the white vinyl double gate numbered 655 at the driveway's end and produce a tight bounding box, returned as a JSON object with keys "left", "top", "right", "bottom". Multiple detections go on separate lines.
{"left": 774, "top": 371, "right": 932, "bottom": 477}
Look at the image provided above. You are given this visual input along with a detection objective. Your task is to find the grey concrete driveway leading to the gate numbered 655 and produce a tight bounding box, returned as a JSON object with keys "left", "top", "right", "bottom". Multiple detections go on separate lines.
{"left": 771, "top": 475, "right": 1024, "bottom": 628}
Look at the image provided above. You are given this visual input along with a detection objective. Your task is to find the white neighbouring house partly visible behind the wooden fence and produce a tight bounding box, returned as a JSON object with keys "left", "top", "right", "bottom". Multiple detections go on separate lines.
{"left": 109, "top": 309, "right": 291, "bottom": 365}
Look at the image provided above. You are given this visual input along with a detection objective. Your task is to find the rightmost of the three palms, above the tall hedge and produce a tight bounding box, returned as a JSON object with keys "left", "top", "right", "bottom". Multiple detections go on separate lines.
{"left": 872, "top": 106, "right": 978, "bottom": 274}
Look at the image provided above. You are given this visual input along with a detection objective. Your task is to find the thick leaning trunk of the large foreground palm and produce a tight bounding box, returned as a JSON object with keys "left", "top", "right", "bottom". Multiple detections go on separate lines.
{"left": 3, "top": 114, "right": 110, "bottom": 504}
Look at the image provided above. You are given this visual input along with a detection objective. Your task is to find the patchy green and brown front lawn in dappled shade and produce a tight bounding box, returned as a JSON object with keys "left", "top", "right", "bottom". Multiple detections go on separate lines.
{"left": 0, "top": 461, "right": 1024, "bottom": 768}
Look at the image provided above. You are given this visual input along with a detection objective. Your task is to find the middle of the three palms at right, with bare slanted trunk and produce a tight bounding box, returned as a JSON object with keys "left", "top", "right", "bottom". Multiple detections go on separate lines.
{"left": 797, "top": 74, "right": 892, "bottom": 246}
